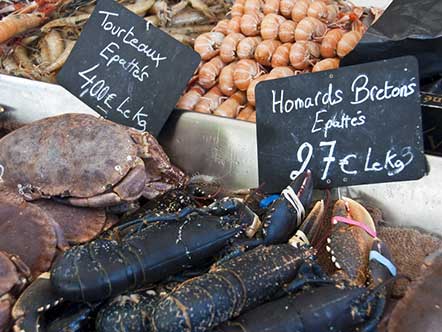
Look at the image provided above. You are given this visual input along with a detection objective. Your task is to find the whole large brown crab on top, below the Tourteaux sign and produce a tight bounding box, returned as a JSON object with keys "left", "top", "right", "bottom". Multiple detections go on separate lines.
{"left": 0, "top": 114, "right": 187, "bottom": 207}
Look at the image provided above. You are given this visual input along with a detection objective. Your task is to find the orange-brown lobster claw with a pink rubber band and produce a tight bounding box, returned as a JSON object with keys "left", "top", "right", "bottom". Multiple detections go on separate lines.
{"left": 326, "top": 198, "right": 376, "bottom": 285}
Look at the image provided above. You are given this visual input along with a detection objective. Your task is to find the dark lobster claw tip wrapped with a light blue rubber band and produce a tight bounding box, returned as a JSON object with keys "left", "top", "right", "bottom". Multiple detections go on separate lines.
{"left": 368, "top": 239, "right": 397, "bottom": 287}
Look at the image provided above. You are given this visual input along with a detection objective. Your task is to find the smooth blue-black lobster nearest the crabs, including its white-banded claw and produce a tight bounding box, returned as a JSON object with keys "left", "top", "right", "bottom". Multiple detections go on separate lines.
{"left": 51, "top": 171, "right": 313, "bottom": 302}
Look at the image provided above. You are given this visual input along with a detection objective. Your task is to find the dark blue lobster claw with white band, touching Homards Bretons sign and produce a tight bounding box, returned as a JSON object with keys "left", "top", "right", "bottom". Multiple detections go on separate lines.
{"left": 263, "top": 170, "right": 313, "bottom": 245}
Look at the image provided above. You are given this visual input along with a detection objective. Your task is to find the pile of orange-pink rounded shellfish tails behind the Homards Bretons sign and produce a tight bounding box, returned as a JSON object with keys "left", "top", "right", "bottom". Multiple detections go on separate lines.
{"left": 177, "top": 0, "right": 380, "bottom": 121}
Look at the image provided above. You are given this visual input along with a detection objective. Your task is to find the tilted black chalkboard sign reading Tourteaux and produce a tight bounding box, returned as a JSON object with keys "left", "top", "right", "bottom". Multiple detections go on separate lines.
{"left": 57, "top": 0, "right": 200, "bottom": 136}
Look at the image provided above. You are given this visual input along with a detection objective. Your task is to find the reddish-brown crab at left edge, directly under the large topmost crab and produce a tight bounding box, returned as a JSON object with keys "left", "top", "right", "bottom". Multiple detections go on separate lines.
{"left": 0, "top": 191, "right": 66, "bottom": 277}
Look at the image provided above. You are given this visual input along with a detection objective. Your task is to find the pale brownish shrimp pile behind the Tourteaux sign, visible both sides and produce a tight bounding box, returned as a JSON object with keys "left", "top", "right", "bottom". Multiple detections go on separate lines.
{"left": 0, "top": 0, "right": 231, "bottom": 82}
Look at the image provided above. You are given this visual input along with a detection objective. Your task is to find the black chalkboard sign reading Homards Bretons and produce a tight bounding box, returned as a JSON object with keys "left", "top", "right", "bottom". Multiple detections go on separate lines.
{"left": 256, "top": 57, "right": 426, "bottom": 192}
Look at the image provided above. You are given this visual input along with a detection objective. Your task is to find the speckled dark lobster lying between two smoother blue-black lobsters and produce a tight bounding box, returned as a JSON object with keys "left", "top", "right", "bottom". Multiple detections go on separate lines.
{"left": 150, "top": 200, "right": 318, "bottom": 332}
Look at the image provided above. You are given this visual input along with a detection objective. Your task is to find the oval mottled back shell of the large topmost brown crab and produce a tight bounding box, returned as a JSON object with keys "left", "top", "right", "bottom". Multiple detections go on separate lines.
{"left": 0, "top": 114, "right": 137, "bottom": 197}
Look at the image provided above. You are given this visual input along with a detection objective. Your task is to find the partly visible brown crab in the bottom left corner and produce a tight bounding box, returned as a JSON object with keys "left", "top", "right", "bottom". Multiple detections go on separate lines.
{"left": 0, "top": 251, "right": 29, "bottom": 332}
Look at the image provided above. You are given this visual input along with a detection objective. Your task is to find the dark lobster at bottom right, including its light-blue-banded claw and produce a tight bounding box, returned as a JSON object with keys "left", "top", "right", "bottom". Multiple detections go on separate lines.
{"left": 215, "top": 239, "right": 396, "bottom": 332}
